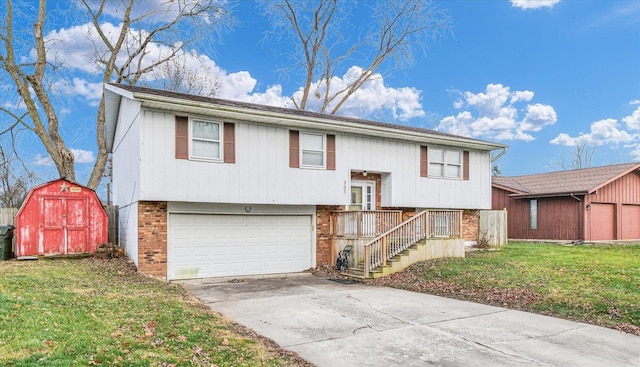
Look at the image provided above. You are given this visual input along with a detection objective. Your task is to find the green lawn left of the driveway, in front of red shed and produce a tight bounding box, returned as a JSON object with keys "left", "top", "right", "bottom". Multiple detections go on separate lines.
{"left": 0, "top": 259, "right": 302, "bottom": 366}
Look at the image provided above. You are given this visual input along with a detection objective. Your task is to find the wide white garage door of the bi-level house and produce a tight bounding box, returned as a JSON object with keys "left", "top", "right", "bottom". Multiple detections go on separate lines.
{"left": 167, "top": 214, "right": 312, "bottom": 279}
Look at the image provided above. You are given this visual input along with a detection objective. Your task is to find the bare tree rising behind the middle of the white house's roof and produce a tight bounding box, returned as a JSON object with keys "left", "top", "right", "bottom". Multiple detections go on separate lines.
{"left": 260, "top": 0, "right": 452, "bottom": 114}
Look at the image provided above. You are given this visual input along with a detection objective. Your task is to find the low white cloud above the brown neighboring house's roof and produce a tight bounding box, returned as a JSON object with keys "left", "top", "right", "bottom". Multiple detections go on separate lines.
{"left": 550, "top": 119, "right": 640, "bottom": 146}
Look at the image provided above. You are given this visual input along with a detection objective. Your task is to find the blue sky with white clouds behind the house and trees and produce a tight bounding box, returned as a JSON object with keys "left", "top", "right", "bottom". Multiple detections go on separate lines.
{"left": 0, "top": 0, "right": 640, "bottom": 190}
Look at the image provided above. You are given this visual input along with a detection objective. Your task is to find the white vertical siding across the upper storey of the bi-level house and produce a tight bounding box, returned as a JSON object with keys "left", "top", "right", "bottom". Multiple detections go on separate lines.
{"left": 135, "top": 110, "right": 491, "bottom": 209}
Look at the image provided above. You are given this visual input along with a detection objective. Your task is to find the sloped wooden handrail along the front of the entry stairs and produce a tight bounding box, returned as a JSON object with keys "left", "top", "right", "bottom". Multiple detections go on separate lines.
{"left": 363, "top": 210, "right": 429, "bottom": 278}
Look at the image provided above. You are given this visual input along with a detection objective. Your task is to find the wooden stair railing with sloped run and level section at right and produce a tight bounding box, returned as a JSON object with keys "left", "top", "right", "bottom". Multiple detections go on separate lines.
{"left": 364, "top": 210, "right": 462, "bottom": 278}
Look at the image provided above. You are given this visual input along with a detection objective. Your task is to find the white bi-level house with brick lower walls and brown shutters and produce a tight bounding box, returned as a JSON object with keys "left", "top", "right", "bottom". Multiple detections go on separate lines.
{"left": 104, "top": 84, "right": 505, "bottom": 280}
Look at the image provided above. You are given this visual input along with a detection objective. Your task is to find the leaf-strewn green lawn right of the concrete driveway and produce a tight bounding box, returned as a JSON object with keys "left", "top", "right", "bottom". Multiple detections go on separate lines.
{"left": 374, "top": 243, "right": 640, "bottom": 335}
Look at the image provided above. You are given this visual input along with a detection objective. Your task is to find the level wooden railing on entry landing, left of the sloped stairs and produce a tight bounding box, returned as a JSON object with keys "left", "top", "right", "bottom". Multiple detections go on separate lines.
{"left": 332, "top": 210, "right": 402, "bottom": 238}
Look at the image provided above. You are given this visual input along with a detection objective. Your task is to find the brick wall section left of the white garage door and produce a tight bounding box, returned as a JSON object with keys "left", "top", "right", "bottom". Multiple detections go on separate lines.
{"left": 138, "top": 201, "right": 167, "bottom": 279}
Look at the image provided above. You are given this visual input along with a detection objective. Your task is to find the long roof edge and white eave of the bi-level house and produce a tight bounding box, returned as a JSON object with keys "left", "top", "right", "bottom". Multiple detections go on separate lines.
{"left": 105, "top": 83, "right": 507, "bottom": 151}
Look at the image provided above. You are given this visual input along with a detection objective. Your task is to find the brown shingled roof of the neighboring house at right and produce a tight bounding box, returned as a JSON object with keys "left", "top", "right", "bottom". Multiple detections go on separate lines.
{"left": 491, "top": 162, "right": 640, "bottom": 197}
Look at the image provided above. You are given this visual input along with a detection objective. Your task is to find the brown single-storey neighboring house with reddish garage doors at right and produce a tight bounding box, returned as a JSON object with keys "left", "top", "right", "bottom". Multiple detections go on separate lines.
{"left": 491, "top": 162, "right": 640, "bottom": 241}
